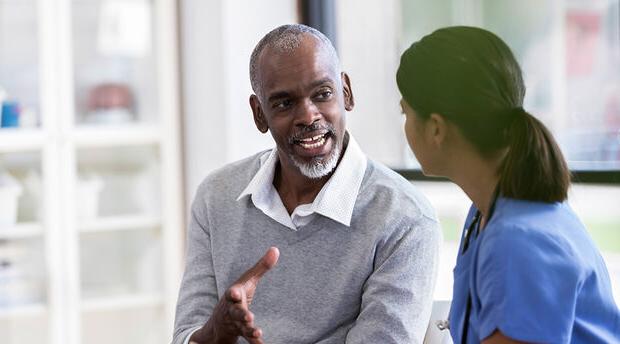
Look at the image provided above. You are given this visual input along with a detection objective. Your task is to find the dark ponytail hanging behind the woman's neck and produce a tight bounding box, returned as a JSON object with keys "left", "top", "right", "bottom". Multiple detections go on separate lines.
{"left": 499, "top": 108, "right": 570, "bottom": 203}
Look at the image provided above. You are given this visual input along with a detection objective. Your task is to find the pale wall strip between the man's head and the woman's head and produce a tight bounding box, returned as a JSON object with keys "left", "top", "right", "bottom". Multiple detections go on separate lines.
{"left": 336, "top": 0, "right": 408, "bottom": 167}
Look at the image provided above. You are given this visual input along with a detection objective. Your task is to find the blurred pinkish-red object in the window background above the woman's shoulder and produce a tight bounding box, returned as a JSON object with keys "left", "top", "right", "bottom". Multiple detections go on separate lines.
{"left": 566, "top": 10, "right": 601, "bottom": 76}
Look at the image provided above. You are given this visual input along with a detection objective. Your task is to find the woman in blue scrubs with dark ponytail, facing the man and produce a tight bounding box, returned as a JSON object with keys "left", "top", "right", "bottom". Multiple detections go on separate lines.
{"left": 397, "top": 27, "right": 620, "bottom": 343}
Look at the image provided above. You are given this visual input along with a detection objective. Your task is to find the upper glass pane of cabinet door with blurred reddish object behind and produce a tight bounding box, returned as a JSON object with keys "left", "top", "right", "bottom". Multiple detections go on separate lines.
{"left": 72, "top": 0, "right": 158, "bottom": 125}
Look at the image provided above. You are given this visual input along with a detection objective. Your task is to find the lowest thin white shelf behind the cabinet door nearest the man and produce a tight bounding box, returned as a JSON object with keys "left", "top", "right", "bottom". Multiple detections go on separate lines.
{"left": 82, "top": 293, "right": 164, "bottom": 312}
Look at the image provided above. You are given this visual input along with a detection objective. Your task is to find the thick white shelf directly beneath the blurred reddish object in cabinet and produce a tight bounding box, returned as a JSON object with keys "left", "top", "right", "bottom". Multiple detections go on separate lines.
{"left": 73, "top": 124, "right": 161, "bottom": 148}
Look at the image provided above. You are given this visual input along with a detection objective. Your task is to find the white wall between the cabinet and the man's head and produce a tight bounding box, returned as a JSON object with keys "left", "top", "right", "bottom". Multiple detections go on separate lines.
{"left": 181, "top": 0, "right": 298, "bottom": 202}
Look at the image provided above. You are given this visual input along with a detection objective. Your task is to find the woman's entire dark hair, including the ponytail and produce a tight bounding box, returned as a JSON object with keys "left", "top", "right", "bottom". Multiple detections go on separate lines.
{"left": 396, "top": 26, "right": 570, "bottom": 202}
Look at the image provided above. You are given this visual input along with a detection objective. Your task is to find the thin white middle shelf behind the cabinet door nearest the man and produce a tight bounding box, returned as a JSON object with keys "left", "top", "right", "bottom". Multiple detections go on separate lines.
{"left": 78, "top": 215, "right": 161, "bottom": 233}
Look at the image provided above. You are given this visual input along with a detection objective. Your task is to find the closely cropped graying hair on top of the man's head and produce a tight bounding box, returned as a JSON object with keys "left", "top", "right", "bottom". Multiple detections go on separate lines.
{"left": 250, "top": 24, "right": 340, "bottom": 98}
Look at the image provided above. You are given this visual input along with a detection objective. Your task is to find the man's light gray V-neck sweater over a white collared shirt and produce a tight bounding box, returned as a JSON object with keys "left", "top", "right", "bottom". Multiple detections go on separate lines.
{"left": 173, "top": 154, "right": 441, "bottom": 344}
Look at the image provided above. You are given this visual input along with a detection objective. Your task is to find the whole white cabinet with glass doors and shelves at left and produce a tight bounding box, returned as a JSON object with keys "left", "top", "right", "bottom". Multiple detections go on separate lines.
{"left": 0, "top": 0, "right": 184, "bottom": 344}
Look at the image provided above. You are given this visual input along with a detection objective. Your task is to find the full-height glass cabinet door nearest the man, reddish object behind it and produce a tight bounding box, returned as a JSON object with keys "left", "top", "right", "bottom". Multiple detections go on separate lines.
{"left": 71, "top": 0, "right": 169, "bottom": 343}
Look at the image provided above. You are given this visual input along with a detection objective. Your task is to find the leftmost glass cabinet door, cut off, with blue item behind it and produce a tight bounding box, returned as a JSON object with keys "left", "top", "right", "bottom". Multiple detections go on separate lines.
{"left": 0, "top": 0, "right": 50, "bottom": 344}
